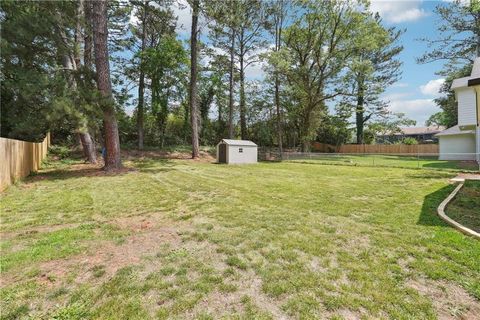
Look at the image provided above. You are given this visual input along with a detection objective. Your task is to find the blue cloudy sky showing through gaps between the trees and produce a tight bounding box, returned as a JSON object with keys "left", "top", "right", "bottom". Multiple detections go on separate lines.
{"left": 148, "top": 0, "right": 460, "bottom": 126}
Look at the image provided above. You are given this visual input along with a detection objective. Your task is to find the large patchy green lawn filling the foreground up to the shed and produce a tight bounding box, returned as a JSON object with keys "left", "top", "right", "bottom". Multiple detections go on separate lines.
{"left": 0, "top": 159, "right": 480, "bottom": 319}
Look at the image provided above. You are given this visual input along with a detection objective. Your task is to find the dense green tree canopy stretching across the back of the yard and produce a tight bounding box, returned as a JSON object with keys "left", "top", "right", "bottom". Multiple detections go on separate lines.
{"left": 0, "top": 0, "right": 442, "bottom": 156}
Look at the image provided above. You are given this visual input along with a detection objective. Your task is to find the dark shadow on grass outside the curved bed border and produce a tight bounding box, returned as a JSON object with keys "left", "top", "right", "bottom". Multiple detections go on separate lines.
{"left": 417, "top": 184, "right": 455, "bottom": 227}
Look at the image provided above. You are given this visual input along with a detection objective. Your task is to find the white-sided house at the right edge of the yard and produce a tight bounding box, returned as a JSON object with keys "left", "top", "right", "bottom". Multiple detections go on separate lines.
{"left": 436, "top": 58, "right": 480, "bottom": 163}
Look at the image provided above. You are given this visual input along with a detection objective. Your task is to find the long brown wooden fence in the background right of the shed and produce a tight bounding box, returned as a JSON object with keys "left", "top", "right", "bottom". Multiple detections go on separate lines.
{"left": 312, "top": 142, "right": 439, "bottom": 154}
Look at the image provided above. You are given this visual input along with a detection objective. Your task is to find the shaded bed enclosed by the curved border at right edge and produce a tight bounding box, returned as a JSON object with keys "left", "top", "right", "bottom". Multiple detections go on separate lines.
{"left": 446, "top": 180, "right": 480, "bottom": 233}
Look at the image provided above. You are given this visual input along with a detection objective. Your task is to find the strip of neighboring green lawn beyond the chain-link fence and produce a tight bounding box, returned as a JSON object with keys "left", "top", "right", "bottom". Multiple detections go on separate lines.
{"left": 286, "top": 153, "right": 479, "bottom": 172}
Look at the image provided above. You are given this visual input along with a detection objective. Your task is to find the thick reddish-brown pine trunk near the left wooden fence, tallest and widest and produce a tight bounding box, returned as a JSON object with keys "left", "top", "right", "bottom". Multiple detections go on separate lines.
{"left": 93, "top": 0, "right": 122, "bottom": 171}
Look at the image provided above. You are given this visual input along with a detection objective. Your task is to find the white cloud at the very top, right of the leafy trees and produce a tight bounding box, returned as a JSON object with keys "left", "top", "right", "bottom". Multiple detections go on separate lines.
{"left": 370, "top": 0, "right": 428, "bottom": 23}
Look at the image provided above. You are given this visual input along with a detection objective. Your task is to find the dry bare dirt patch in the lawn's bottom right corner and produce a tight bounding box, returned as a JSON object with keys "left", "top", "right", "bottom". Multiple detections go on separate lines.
{"left": 407, "top": 279, "right": 480, "bottom": 320}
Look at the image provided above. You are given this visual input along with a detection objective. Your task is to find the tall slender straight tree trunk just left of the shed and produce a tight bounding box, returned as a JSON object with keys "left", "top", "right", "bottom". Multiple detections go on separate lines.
{"left": 189, "top": 0, "right": 200, "bottom": 159}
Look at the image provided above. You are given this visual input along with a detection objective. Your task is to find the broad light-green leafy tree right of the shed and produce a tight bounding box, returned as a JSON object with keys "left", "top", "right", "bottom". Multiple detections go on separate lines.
{"left": 269, "top": 1, "right": 390, "bottom": 148}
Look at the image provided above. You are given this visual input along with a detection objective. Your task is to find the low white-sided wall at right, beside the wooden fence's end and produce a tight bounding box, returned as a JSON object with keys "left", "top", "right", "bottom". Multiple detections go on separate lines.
{"left": 439, "top": 134, "right": 475, "bottom": 160}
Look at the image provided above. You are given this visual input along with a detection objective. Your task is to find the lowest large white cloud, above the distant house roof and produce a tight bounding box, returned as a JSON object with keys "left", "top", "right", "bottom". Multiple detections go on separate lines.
{"left": 389, "top": 99, "right": 440, "bottom": 126}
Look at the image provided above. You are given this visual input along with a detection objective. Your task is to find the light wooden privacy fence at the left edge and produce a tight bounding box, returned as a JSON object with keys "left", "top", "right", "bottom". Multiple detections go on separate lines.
{"left": 0, "top": 133, "right": 50, "bottom": 191}
